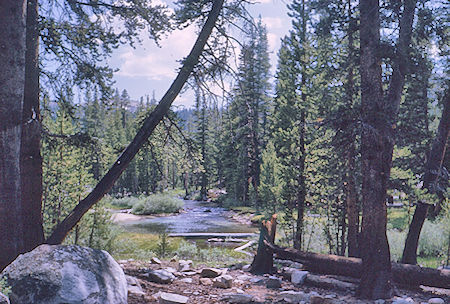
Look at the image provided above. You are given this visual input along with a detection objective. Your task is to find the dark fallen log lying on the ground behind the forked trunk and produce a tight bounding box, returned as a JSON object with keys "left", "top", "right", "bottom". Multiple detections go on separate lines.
{"left": 264, "top": 241, "right": 450, "bottom": 289}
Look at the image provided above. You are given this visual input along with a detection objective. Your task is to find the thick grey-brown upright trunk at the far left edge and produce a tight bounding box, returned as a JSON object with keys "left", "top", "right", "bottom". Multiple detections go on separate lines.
{"left": 0, "top": 0, "right": 28, "bottom": 271}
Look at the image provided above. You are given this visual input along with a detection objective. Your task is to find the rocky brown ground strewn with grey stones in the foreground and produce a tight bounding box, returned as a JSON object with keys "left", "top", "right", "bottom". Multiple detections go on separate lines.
{"left": 119, "top": 259, "right": 450, "bottom": 304}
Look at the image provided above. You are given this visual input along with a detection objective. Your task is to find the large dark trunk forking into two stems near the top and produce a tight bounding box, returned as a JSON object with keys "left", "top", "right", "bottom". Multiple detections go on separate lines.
{"left": 358, "top": 0, "right": 417, "bottom": 299}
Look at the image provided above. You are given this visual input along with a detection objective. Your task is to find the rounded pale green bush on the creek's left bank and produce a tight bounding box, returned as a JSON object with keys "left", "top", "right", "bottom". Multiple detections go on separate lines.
{"left": 131, "top": 194, "right": 184, "bottom": 215}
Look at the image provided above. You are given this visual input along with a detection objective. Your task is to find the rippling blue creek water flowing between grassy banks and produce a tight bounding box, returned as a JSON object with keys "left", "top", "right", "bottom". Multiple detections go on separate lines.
{"left": 121, "top": 200, "right": 257, "bottom": 234}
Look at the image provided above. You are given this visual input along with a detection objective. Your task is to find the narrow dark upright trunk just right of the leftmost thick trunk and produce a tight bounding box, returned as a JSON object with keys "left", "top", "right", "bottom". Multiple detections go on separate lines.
{"left": 20, "top": 0, "right": 44, "bottom": 252}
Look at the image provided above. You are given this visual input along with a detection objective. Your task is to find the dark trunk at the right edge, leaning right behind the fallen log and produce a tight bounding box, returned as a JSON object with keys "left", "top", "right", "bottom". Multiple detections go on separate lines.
{"left": 402, "top": 89, "right": 450, "bottom": 264}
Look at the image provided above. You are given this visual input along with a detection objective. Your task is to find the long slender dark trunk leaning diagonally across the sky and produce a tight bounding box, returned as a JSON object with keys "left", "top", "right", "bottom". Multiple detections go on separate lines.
{"left": 46, "top": 0, "right": 223, "bottom": 244}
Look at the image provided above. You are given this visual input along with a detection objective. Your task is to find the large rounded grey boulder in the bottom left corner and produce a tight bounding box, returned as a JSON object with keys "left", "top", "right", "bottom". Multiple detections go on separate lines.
{"left": 2, "top": 245, "right": 127, "bottom": 304}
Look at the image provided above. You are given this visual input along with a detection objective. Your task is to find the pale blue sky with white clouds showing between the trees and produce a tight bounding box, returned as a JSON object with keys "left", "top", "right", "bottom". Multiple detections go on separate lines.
{"left": 109, "top": 0, "right": 291, "bottom": 107}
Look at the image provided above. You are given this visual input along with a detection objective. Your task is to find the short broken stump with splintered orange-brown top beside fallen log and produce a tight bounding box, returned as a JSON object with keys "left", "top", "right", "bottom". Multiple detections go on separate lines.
{"left": 250, "top": 214, "right": 277, "bottom": 274}
